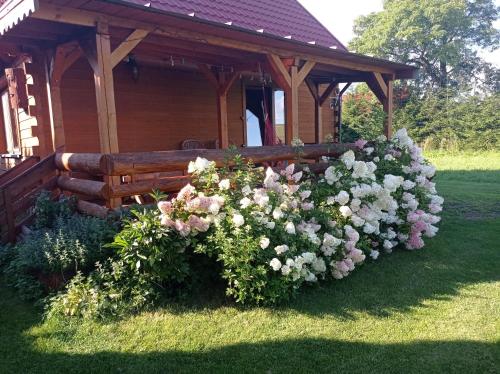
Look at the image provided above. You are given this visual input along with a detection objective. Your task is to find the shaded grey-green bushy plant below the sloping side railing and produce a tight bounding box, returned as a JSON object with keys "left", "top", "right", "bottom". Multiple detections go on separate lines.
{"left": 0, "top": 194, "right": 117, "bottom": 299}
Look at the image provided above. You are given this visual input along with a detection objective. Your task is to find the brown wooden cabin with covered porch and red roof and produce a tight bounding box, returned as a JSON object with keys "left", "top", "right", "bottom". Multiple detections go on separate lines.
{"left": 0, "top": 0, "right": 415, "bottom": 241}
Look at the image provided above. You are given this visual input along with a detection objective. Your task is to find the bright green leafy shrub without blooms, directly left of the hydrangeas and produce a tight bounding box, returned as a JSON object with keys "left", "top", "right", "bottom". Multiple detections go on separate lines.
{"left": 48, "top": 208, "right": 190, "bottom": 317}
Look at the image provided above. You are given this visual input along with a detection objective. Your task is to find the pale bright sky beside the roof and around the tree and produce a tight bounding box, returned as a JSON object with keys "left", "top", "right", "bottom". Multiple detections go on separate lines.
{"left": 299, "top": 0, "right": 500, "bottom": 67}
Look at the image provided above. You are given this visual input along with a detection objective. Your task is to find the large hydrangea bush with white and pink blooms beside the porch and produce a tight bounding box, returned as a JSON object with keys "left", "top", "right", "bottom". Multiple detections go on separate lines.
{"left": 48, "top": 130, "right": 443, "bottom": 316}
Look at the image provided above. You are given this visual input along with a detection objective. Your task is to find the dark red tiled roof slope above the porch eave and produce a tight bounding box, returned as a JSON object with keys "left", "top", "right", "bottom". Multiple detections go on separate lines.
{"left": 125, "top": 0, "right": 346, "bottom": 50}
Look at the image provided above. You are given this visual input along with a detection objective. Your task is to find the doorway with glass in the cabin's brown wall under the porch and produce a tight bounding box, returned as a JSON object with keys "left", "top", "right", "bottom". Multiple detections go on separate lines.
{"left": 245, "top": 87, "right": 285, "bottom": 147}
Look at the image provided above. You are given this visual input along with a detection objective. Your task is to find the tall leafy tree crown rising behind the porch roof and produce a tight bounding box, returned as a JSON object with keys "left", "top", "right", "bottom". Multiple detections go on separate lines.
{"left": 349, "top": 0, "right": 500, "bottom": 90}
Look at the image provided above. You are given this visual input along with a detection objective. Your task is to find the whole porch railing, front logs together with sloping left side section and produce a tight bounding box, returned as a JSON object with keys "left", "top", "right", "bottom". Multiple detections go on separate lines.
{"left": 0, "top": 143, "right": 354, "bottom": 243}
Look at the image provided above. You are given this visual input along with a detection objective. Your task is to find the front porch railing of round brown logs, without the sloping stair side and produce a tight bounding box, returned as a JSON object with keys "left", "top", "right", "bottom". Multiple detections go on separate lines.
{"left": 55, "top": 143, "right": 353, "bottom": 207}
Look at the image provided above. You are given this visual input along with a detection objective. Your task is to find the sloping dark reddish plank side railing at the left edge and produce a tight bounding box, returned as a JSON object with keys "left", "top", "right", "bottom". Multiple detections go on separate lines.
{"left": 0, "top": 155, "right": 58, "bottom": 243}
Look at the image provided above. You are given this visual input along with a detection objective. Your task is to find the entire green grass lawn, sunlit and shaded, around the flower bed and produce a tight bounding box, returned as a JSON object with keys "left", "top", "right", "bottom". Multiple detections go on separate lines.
{"left": 0, "top": 153, "right": 500, "bottom": 374}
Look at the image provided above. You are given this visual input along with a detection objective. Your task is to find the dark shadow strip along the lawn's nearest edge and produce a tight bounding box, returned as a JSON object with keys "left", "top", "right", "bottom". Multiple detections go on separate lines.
{"left": 0, "top": 332, "right": 499, "bottom": 374}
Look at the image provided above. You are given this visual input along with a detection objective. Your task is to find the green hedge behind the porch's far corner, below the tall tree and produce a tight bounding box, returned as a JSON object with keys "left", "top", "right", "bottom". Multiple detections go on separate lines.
{"left": 342, "top": 85, "right": 500, "bottom": 150}
